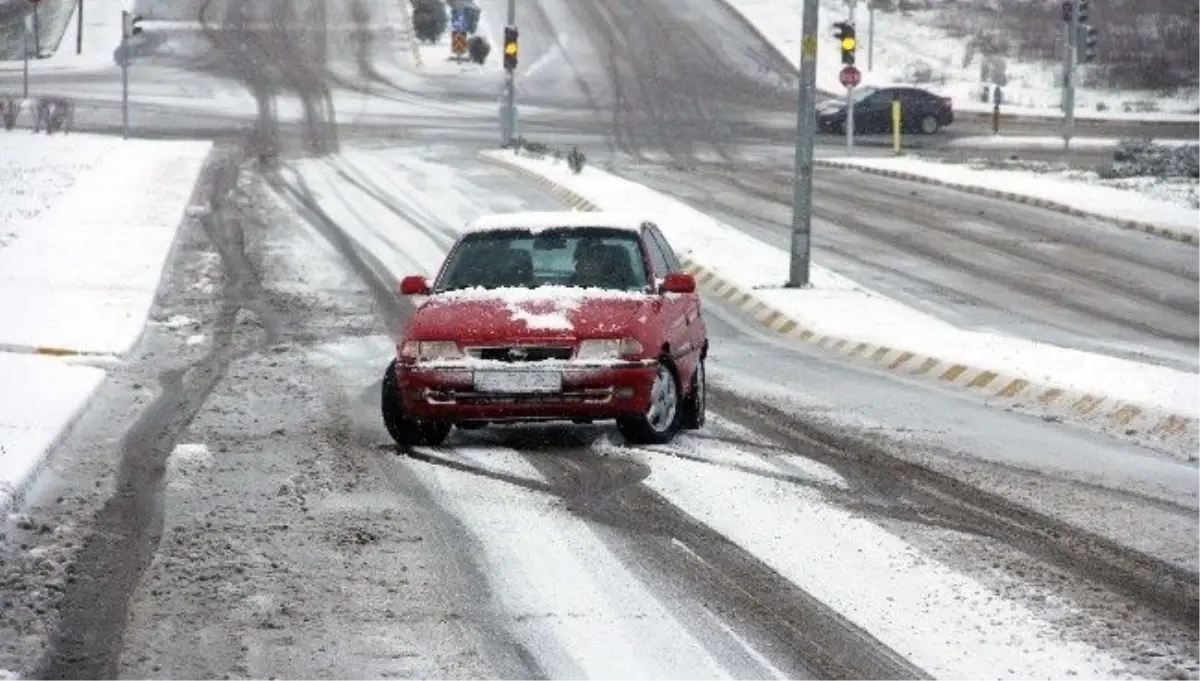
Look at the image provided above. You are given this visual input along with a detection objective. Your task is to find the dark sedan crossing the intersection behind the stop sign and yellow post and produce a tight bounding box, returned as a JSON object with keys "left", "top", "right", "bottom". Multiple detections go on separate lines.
{"left": 817, "top": 85, "right": 954, "bottom": 134}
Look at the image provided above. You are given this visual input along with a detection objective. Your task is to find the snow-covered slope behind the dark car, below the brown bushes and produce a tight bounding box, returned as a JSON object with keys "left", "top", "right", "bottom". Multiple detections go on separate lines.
{"left": 727, "top": 0, "right": 1200, "bottom": 121}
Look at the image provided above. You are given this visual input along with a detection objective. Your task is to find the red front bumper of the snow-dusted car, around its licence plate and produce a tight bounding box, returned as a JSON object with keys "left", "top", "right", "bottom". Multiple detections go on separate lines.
{"left": 396, "top": 361, "right": 658, "bottom": 422}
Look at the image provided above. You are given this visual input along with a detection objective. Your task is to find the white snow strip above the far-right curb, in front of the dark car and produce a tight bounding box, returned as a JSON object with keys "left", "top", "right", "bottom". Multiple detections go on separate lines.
{"left": 822, "top": 157, "right": 1200, "bottom": 237}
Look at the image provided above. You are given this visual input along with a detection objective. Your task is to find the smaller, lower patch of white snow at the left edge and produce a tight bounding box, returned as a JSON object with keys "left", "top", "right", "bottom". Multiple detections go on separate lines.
{"left": 0, "top": 352, "right": 104, "bottom": 508}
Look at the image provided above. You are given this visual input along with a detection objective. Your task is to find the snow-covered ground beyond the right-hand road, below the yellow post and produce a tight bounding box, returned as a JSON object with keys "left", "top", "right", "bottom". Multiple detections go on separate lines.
{"left": 822, "top": 152, "right": 1200, "bottom": 231}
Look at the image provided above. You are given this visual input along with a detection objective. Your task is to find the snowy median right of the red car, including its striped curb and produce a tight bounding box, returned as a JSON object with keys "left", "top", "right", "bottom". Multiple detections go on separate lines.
{"left": 481, "top": 151, "right": 1200, "bottom": 451}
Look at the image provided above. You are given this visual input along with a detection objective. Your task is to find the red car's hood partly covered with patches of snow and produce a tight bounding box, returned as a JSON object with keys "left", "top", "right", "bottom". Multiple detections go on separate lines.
{"left": 406, "top": 287, "right": 654, "bottom": 344}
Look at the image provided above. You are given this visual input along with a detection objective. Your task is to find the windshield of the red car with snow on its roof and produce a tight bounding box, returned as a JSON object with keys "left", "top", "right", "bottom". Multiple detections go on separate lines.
{"left": 433, "top": 227, "right": 647, "bottom": 291}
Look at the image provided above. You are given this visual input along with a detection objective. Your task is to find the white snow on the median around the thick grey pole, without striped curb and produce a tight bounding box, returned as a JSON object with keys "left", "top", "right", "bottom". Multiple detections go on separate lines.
{"left": 484, "top": 151, "right": 1200, "bottom": 417}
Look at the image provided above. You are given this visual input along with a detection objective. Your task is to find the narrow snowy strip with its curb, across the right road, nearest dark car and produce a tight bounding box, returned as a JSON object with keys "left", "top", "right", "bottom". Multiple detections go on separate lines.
{"left": 815, "top": 158, "right": 1200, "bottom": 243}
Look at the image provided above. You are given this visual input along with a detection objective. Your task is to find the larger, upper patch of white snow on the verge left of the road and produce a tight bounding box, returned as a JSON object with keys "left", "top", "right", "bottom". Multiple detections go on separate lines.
{"left": 0, "top": 134, "right": 211, "bottom": 354}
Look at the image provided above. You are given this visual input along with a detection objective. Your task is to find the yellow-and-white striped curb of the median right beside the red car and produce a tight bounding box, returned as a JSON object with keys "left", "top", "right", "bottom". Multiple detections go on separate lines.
{"left": 481, "top": 153, "right": 1200, "bottom": 455}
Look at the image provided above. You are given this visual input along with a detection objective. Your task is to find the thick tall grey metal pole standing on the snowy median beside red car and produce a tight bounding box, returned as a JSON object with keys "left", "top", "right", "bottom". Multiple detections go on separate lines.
{"left": 787, "top": 0, "right": 820, "bottom": 288}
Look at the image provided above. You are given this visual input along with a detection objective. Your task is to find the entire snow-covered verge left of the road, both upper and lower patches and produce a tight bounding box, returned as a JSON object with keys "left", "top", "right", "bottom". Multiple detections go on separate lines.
{"left": 0, "top": 133, "right": 211, "bottom": 505}
